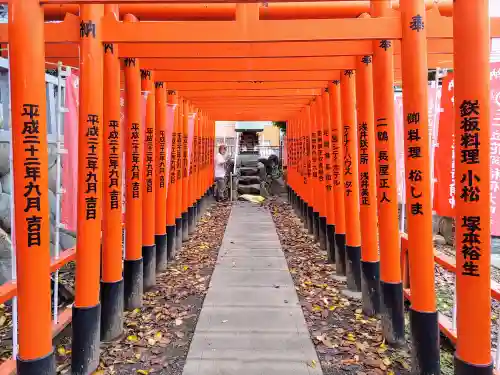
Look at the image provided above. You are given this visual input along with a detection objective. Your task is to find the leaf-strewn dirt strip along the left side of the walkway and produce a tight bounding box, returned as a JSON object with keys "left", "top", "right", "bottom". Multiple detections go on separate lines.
{"left": 53, "top": 204, "right": 230, "bottom": 375}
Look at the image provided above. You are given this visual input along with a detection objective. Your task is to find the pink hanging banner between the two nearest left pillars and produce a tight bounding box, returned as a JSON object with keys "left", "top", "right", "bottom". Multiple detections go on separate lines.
{"left": 61, "top": 74, "right": 79, "bottom": 231}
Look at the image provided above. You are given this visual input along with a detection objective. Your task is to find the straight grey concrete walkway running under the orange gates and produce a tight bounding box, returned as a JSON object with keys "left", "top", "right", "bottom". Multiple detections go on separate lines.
{"left": 183, "top": 202, "right": 322, "bottom": 375}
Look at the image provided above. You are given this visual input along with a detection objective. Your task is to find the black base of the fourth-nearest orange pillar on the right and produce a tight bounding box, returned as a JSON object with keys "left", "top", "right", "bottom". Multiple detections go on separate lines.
{"left": 361, "top": 261, "right": 380, "bottom": 316}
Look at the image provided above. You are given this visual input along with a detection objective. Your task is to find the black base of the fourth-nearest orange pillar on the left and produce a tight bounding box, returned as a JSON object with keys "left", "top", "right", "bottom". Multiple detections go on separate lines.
{"left": 123, "top": 258, "right": 144, "bottom": 311}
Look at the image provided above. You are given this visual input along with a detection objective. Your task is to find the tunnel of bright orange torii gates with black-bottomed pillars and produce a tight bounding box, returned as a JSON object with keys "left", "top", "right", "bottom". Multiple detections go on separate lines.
{"left": 0, "top": 0, "right": 500, "bottom": 375}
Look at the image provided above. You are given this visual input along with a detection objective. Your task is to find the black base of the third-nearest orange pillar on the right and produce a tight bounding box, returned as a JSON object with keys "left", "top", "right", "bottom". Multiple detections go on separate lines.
{"left": 380, "top": 280, "right": 405, "bottom": 346}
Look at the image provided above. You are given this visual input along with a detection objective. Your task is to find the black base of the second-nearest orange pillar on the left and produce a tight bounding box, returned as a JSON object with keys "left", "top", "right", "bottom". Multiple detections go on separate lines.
{"left": 71, "top": 304, "right": 101, "bottom": 375}
